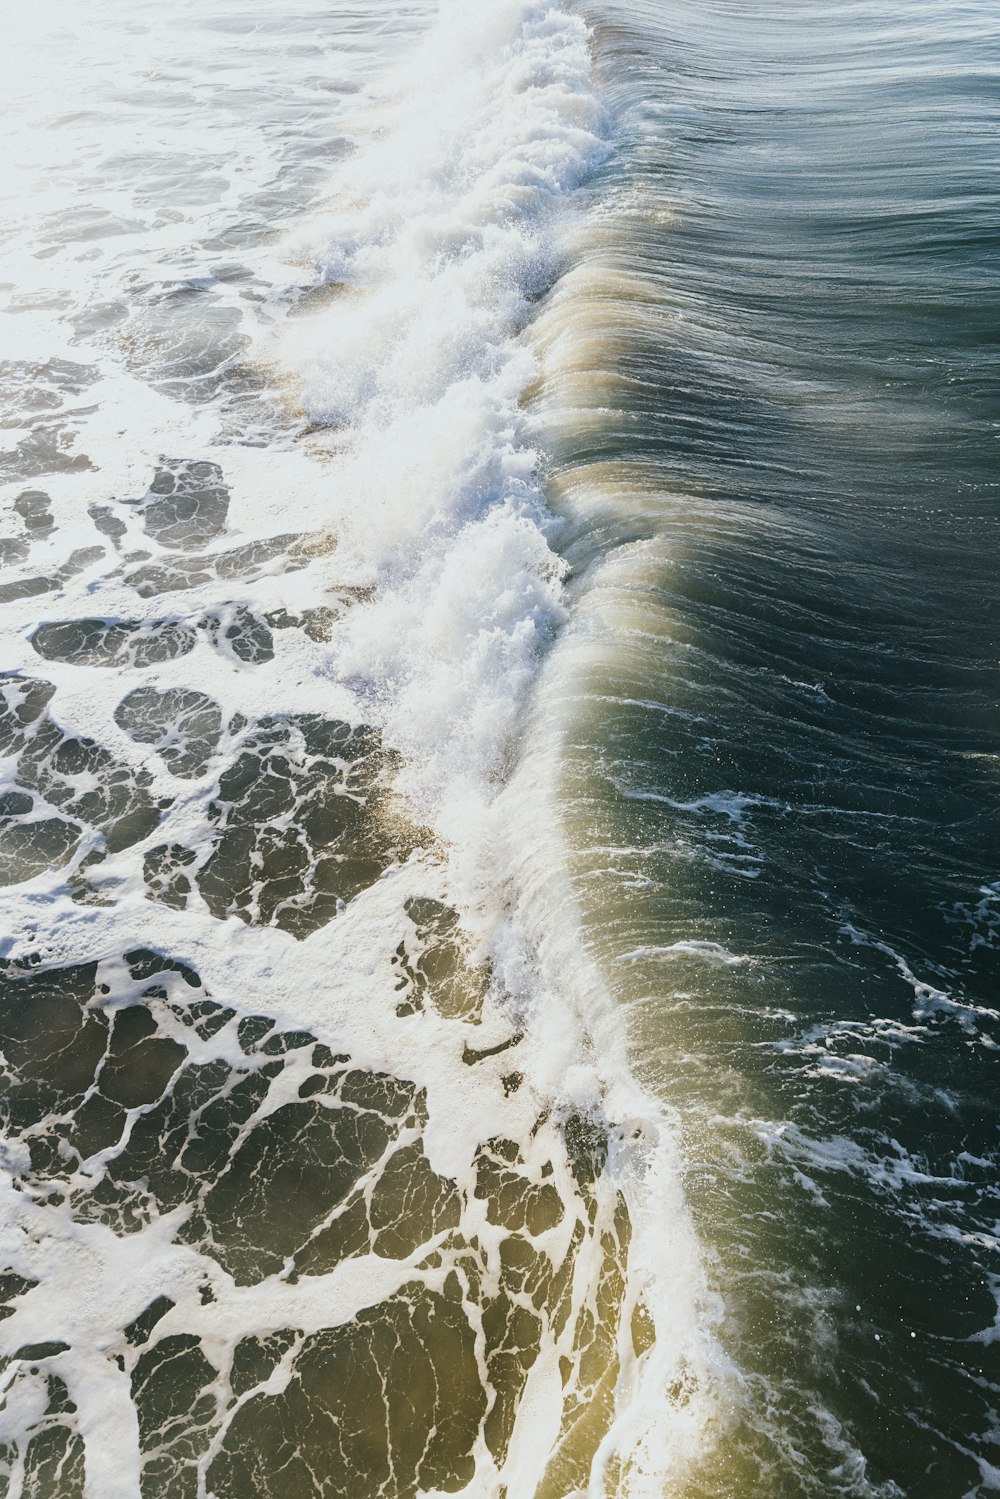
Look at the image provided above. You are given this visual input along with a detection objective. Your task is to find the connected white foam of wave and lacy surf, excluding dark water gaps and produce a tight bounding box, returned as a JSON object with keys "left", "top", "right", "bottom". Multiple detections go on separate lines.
{"left": 0, "top": 0, "right": 732, "bottom": 1499}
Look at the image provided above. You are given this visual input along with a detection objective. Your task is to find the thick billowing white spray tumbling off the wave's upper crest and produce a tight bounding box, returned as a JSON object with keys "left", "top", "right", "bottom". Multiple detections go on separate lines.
{"left": 271, "top": 0, "right": 617, "bottom": 844}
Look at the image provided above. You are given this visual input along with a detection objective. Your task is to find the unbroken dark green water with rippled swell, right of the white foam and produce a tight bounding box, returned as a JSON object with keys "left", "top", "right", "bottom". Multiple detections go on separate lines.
{"left": 535, "top": 0, "right": 1000, "bottom": 1499}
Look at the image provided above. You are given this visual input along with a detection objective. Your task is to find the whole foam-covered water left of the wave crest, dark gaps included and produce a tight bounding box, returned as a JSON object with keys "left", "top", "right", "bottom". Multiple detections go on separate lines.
{"left": 0, "top": 0, "right": 727, "bottom": 1499}
